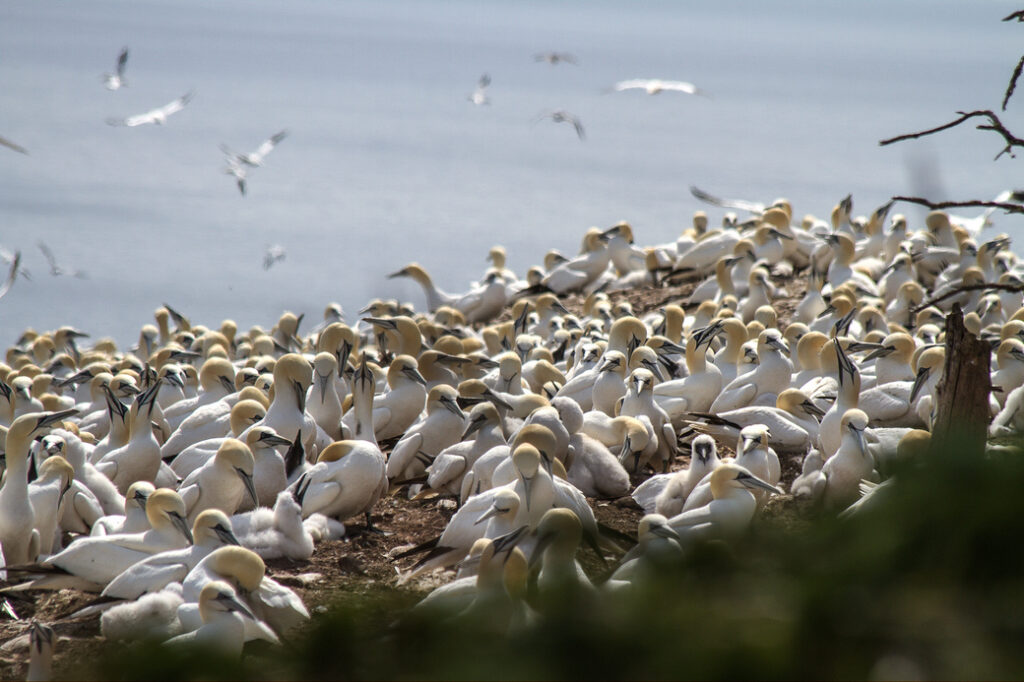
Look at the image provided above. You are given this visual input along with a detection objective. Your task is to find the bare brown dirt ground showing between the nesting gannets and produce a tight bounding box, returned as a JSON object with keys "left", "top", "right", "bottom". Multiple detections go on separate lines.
{"left": 0, "top": 268, "right": 804, "bottom": 680}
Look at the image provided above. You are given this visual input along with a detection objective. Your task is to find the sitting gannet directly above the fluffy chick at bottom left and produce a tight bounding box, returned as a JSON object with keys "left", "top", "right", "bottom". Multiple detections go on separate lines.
{"left": 102, "top": 509, "right": 240, "bottom": 599}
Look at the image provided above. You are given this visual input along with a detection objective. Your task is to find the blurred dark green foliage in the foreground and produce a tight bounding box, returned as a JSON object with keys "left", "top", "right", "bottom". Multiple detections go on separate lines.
{"left": 90, "top": 432, "right": 1024, "bottom": 680}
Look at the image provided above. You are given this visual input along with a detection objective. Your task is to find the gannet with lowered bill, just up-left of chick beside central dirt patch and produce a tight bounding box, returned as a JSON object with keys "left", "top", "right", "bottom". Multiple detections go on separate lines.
{"left": 178, "top": 438, "right": 256, "bottom": 521}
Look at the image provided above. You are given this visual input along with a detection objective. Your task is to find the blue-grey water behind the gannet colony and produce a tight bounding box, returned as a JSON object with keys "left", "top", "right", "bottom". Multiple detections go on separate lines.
{"left": 0, "top": 0, "right": 1024, "bottom": 344}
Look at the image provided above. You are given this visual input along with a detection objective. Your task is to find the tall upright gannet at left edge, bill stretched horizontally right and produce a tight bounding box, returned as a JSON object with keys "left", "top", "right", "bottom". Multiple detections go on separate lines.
{"left": 0, "top": 410, "right": 76, "bottom": 565}
